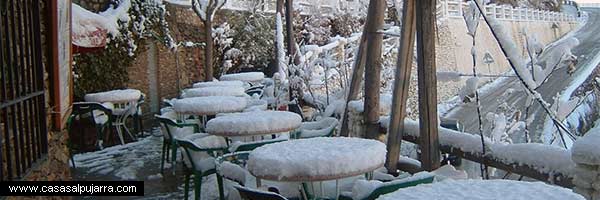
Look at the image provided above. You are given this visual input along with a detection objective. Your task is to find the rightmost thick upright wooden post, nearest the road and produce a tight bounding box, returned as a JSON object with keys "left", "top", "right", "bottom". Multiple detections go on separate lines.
{"left": 416, "top": 0, "right": 440, "bottom": 171}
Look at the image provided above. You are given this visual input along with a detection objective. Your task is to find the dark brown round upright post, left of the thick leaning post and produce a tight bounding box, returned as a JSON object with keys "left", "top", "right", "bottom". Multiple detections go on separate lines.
{"left": 363, "top": 0, "right": 387, "bottom": 139}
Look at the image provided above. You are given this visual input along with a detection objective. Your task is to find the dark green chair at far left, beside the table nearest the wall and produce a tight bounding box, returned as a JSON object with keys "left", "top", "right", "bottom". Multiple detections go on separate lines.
{"left": 67, "top": 102, "right": 113, "bottom": 166}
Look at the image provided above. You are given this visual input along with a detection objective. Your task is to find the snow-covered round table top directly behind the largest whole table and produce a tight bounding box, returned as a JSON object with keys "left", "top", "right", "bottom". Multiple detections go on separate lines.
{"left": 206, "top": 111, "right": 302, "bottom": 137}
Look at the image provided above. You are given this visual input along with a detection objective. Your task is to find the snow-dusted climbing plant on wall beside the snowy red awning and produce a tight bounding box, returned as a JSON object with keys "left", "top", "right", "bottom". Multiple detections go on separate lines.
{"left": 73, "top": 0, "right": 176, "bottom": 99}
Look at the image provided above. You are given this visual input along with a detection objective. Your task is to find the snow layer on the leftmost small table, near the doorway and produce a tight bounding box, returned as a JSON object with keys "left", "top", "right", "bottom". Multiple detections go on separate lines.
{"left": 84, "top": 89, "right": 142, "bottom": 103}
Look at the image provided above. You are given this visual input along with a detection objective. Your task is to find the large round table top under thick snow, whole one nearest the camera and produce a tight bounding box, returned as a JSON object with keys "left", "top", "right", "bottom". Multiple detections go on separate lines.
{"left": 248, "top": 137, "right": 387, "bottom": 182}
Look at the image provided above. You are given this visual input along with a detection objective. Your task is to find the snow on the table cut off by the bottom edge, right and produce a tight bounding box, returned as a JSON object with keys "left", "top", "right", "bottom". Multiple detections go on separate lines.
{"left": 377, "top": 179, "right": 584, "bottom": 200}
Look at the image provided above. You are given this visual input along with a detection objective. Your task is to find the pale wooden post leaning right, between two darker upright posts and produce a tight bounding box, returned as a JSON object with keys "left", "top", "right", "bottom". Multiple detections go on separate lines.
{"left": 385, "top": 0, "right": 416, "bottom": 173}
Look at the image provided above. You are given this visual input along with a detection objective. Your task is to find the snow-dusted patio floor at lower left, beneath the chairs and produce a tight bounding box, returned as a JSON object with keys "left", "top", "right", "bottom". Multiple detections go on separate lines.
{"left": 72, "top": 127, "right": 244, "bottom": 200}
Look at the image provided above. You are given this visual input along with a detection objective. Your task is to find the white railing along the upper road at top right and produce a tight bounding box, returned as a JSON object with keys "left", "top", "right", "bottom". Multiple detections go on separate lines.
{"left": 437, "top": 0, "right": 579, "bottom": 22}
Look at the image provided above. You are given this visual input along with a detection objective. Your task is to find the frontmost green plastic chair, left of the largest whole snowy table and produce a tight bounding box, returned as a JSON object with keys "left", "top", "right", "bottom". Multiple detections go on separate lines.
{"left": 176, "top": 135, "right": 230, "bottom": 200}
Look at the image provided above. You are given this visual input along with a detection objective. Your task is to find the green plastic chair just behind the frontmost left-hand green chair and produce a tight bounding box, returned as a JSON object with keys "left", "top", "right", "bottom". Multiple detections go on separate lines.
{"left": 154, "top": 113, "right": 200, "bottom": 173}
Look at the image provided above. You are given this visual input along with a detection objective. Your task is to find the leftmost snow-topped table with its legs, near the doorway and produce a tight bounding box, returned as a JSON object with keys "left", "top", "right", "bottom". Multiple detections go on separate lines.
{"left": 84, "top": 89, "right": 142, "bottom": 144}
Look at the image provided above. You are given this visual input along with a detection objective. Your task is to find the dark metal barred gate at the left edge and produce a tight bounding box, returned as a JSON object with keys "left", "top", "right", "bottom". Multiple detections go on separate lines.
{"left": 0, "top": 0, "right": 48, "bottom": 181}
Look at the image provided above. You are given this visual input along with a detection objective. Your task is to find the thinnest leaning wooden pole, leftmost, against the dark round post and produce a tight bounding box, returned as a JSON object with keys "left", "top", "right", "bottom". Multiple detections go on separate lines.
{"left": 340, "top": 27, "right": 369, "bottom": 137}
